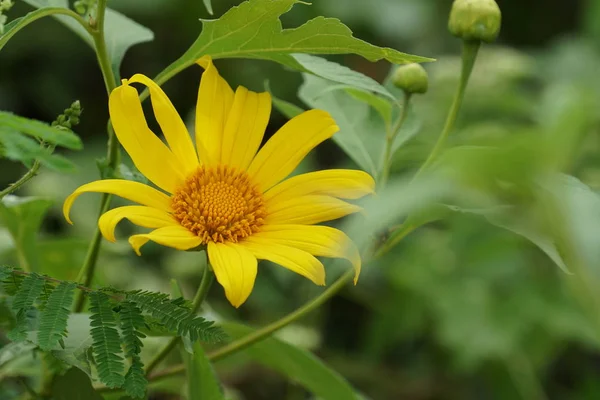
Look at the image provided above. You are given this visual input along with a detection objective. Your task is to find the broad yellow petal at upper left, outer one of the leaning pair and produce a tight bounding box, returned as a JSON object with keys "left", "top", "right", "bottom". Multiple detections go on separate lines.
{"left": 108, "top": 80, "right": 185, "bottom": 193}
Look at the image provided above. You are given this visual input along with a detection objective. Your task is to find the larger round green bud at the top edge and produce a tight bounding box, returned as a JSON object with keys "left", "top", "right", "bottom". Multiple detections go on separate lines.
{"left": 448, "top": 0, "right": 502, "bottom": 42}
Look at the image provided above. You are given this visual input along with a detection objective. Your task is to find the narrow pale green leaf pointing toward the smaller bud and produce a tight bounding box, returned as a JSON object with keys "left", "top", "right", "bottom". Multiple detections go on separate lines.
{"left": 293, "top": 54, "right": 396, "bottom": 102}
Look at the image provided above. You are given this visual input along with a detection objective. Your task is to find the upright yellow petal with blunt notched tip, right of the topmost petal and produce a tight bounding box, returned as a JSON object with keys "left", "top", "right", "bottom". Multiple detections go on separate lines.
{"left": 221, "top": 86, "right": 271, "bottom": 171}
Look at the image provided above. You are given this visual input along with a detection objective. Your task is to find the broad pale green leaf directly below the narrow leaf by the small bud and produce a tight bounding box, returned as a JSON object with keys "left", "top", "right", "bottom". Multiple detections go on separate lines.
{"left": 298, "top": 74, "right": 386, "bottom": 176}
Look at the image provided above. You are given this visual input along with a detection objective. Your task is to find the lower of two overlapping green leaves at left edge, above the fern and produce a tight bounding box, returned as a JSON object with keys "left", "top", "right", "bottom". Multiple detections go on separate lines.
{"left": 0, "top": 130, "right": 76, "bottom": 172}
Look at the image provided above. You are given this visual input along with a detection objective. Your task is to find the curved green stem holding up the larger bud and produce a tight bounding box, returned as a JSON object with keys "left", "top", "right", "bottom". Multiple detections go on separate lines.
{"left": 415, "top": 41, "right": 481, "bottom": 178}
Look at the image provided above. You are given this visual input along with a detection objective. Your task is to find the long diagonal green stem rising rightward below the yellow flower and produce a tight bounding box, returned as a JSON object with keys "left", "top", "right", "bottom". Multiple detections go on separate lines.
{"left": 149, "top": 270, "right": 354, "bottom": 381}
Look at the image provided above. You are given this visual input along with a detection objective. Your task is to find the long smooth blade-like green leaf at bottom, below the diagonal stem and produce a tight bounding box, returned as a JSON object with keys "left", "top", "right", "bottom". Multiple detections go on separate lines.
{"left": 223, "top": 322, "right": 362, "bottom": 400}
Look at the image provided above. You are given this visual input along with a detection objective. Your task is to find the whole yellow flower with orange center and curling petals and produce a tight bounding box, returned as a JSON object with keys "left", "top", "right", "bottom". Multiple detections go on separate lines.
{"left": 63, "top": 57, "right": 374, "bottom": 307}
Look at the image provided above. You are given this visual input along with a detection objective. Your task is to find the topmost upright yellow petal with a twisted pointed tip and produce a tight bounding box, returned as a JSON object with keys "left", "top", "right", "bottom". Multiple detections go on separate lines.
{"left": 196, "top": 56, "right": 233, "bottom": 165}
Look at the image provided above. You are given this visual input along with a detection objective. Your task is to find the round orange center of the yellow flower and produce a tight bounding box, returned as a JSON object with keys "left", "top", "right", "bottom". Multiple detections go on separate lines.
{"left": 171, "top": 166, "right": 266, "bottom": 244}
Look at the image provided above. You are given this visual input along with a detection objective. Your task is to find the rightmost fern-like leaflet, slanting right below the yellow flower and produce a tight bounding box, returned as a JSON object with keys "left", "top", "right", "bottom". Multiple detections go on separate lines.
{"left": 127, "top": 291, "right": 225, "bottom": 342}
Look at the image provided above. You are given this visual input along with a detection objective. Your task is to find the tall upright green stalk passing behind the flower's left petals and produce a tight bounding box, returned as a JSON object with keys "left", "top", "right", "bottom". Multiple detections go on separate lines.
{"left": 73, "top": 0, "right": 119, "bottom": 312}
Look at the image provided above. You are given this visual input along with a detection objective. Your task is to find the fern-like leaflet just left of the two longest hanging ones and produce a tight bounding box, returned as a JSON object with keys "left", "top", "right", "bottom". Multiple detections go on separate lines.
{"left": 38, "top": 282, "right": 77, "bottom": 351}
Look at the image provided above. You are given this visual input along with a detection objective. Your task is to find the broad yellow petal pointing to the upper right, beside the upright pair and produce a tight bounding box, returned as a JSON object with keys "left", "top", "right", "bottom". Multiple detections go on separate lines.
{"left": 248, "top": 110, "right": 339, "bottom": 192}
